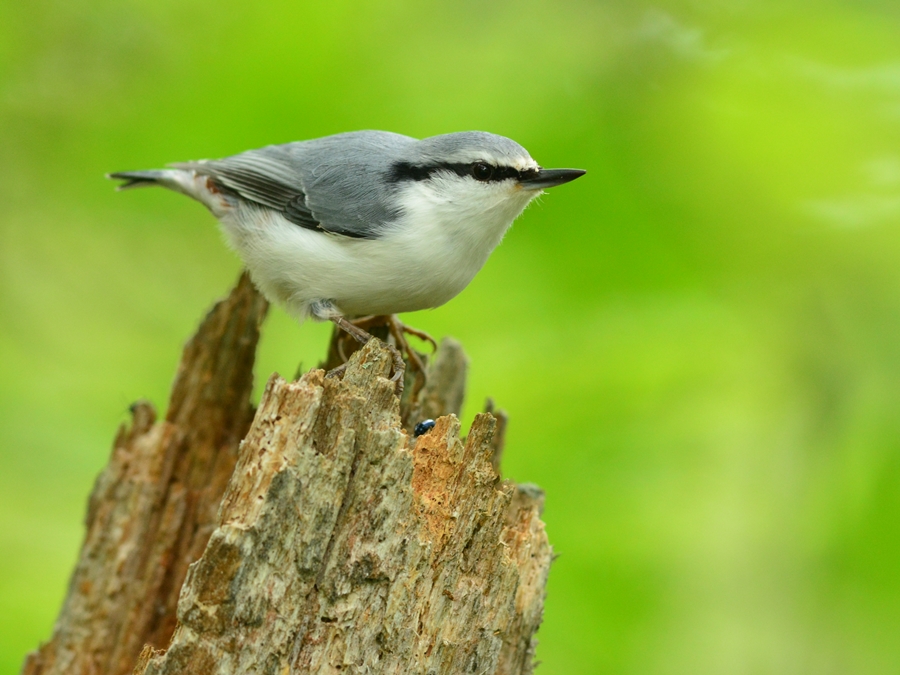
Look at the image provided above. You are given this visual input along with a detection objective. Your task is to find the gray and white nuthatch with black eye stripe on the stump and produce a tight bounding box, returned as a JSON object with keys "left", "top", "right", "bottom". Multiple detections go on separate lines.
{"left": 107, "top": 131, "right": 586, "bottom": 388}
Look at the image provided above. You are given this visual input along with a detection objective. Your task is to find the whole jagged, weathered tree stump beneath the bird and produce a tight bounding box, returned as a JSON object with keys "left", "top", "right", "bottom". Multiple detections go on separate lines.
{"left": 22, "top": 276, "right": 551, "bottom": 675}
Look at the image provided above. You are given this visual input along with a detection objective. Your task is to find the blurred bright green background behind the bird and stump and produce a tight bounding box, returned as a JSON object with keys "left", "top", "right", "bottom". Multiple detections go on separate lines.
{"left": 0, "top": 0, "right": 900, "bottom": 675}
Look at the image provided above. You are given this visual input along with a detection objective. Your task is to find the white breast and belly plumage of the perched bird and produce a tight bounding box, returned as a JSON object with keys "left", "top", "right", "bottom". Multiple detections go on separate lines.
{"left": 214, "top": 176, "right": 536, "bottom": 320}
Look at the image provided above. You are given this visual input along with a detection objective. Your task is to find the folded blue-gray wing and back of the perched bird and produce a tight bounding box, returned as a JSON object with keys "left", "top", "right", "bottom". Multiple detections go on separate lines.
{"left": 174, "top": 131, "right": 415, "bottom": 239}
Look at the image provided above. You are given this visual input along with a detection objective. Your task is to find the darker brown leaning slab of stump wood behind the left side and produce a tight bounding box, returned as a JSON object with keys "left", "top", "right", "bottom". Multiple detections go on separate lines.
{"left": 22, "top": 275, "right": 267, "bottom": 675}
